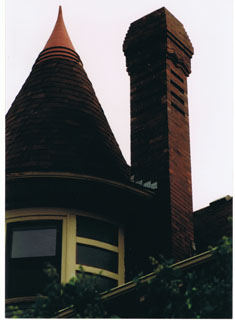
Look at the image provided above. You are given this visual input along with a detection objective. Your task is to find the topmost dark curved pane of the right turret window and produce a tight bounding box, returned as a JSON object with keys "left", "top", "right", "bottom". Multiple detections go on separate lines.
{"left": 77, "top": 216, "right": 118, "bottom": 246}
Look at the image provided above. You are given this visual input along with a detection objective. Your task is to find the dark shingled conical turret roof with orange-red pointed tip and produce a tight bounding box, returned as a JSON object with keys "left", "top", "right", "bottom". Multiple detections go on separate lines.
{"left": 6, "top": 7, "right": 129, "bottom": 181}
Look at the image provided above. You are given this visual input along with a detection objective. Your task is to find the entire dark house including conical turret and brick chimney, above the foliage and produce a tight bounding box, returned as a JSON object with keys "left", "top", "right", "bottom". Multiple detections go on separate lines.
{"left": 6, "top": 7, "right": 231, "bottom": 308}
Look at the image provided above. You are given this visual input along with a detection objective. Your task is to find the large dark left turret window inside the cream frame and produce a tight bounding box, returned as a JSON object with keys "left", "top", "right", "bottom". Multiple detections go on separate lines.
{"left": 6, "top": 220, "right": 62, "bottom": 298}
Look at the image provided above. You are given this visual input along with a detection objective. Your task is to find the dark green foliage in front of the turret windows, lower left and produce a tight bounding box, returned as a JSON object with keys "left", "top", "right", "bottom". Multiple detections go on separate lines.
{"left": 8, "top": 265, "right": 106, "bottom": 318}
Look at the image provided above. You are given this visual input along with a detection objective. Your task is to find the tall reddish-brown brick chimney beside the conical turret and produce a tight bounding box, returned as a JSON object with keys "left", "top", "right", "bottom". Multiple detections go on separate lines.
{"left": 123, "top": 8, "right": 193, "bottom": 260}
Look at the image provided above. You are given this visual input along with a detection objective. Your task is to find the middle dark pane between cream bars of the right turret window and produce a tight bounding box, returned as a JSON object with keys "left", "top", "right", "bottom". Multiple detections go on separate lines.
{"left": 77, "top": 244, "right": 118, "bottom": 273}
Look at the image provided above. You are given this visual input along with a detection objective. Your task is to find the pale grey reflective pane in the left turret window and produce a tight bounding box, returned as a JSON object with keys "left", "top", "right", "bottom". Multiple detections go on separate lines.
{"left": 11, "top": 228, "right": 56, "bottom": 258}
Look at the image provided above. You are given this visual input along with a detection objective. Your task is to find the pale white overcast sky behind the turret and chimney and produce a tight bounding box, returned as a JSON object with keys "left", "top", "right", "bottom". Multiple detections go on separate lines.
{"left": 5, "top": 0, "right": 233, "bottom": 210}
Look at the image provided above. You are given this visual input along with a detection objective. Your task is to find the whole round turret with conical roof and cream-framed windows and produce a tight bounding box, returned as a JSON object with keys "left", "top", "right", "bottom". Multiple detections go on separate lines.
{"left": 6, "top": 7, "right": 129, "bottom": 298}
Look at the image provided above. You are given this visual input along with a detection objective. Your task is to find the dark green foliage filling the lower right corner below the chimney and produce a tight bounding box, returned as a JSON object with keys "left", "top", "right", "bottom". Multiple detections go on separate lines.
{"left": 138, "top": 237, "right": 232, "bottom": 319}
